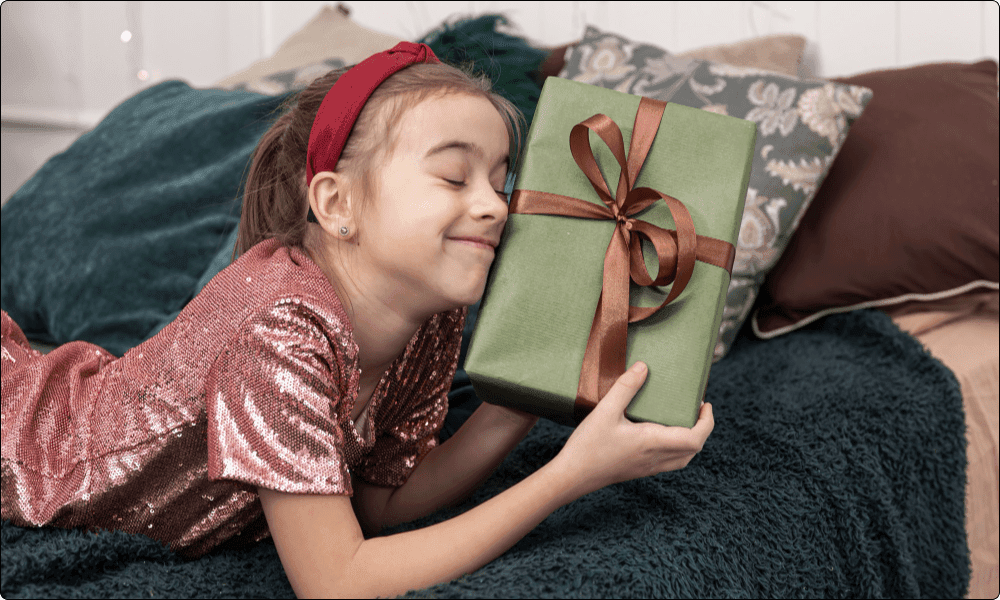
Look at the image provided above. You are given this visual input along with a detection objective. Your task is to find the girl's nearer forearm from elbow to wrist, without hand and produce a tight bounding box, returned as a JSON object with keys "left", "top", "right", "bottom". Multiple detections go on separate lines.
{"left": 345, "top": 461, "right": 579, "bottom": 597}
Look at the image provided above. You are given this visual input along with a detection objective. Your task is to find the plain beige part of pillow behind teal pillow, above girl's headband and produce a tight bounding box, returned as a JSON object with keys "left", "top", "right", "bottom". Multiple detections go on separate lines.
{"left": 214, "top": 6, "right": 403, "bottom": 88}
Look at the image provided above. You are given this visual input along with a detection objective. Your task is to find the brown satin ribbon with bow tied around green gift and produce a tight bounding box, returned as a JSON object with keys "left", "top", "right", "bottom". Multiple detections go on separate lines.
{"left": 508, "top": 98, "right": 736, "bottom": 419}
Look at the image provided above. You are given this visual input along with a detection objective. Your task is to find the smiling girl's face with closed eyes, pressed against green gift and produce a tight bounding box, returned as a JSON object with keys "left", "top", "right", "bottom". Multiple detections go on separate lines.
{"left": 358, "top": 94, "right": 509, "bottom": 315}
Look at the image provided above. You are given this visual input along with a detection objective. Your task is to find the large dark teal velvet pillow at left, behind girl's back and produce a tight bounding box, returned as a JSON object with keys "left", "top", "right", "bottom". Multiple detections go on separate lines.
{"left": 0, "top": 81, "right": 281, "bottom": 355}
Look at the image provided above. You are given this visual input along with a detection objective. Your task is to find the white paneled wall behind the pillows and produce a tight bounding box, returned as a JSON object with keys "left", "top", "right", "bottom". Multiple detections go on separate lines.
{"left": 0, "top": 0, "right": 1000, "bottom": 200}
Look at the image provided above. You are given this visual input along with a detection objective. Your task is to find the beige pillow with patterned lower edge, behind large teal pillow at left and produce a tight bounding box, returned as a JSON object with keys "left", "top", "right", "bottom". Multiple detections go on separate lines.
{"left": 215, "top": 5, "right": 403, "bottom": 94}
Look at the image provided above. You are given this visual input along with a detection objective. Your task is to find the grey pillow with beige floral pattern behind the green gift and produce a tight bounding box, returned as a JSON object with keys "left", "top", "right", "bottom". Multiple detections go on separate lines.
{"left": 559, "top": 27, "right": 872, "bottom": 360}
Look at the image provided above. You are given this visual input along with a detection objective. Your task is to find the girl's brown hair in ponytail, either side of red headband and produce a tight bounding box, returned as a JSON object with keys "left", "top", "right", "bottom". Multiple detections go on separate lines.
{"left": 234, "top": 63, "right": 524, "bottom": 256}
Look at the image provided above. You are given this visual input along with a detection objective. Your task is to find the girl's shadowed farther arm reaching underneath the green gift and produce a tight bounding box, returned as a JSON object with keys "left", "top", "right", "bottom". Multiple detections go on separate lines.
{"left": 353, "top": 403, "right": 538, "bottom": 535}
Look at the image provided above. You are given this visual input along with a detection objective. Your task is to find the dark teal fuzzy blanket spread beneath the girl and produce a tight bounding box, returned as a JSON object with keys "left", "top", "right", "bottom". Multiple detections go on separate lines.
{"left": 2, "top": 311, "right": 969, "bottom": 598}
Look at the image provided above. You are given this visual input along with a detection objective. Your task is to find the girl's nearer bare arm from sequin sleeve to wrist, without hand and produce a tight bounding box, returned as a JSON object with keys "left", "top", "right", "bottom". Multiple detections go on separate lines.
{"left": 259, "top": 446, "right": 571, "bottom": 598}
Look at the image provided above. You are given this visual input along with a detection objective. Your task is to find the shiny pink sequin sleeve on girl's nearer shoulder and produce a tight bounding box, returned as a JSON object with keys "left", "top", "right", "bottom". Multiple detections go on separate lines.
{"left": 206, "top": 298, "right": 353, "bottom": 495}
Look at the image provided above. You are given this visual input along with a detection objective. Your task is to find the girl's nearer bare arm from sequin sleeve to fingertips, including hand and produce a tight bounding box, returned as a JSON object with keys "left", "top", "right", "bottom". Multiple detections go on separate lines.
{"left": 259, "top": 360, "right": 714, "bottom": 597}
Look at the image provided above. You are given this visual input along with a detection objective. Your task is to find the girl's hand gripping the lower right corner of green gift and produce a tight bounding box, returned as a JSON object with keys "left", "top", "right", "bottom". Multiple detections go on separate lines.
{"left": 553, "top": 362, "right": 715, "bottom": 496}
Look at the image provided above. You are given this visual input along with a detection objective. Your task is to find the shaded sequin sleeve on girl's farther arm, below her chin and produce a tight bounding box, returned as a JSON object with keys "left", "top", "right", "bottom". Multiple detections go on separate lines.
{"left": 354, "top": 308, "right": 467, "bottom": 487}
